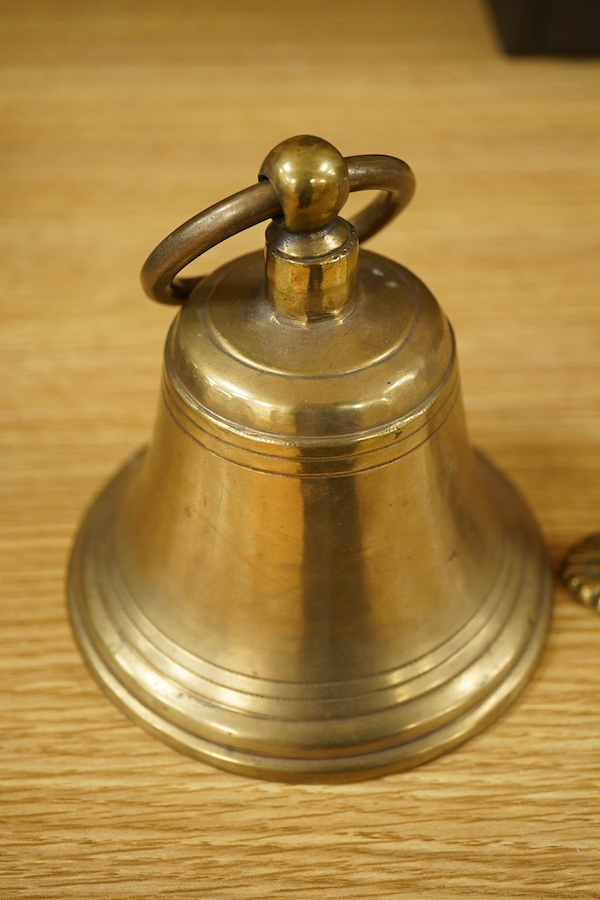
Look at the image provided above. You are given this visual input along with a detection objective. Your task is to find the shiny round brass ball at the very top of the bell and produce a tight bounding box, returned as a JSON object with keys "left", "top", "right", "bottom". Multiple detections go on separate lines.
{"left": 258, "top": 135, "right": 350, "bottom": 233}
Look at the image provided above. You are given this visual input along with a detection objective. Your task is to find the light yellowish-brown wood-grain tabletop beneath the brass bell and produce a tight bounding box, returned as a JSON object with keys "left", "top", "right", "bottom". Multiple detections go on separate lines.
{"left": 0, "top": 0, "right": 600, "bottom": 900}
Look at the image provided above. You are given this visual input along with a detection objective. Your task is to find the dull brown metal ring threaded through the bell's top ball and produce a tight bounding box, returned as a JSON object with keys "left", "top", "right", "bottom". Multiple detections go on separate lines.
{"left": 141, "top": 148, "right": 415, "bottom": 304}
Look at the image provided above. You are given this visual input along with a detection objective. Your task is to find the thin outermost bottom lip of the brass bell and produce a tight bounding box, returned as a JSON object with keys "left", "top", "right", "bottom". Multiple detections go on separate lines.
{"left": 68, "top": 460, "right": 552, "bottom": 783}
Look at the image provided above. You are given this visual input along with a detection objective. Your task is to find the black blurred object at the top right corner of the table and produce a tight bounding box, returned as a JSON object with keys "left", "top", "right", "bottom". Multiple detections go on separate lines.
{"left": 489, "top": 0, "right": 600, "bottom": 54}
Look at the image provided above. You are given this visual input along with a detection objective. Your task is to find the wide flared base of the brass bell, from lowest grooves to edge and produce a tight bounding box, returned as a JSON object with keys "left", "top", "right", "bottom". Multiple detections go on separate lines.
{"left": 68, "top": 451, "right": 552, "bottom": 783}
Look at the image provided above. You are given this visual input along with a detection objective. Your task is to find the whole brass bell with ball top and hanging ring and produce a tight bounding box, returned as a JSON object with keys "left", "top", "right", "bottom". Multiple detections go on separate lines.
{"left": 69, "top": 136, "right": 552, "bottom": 781}
